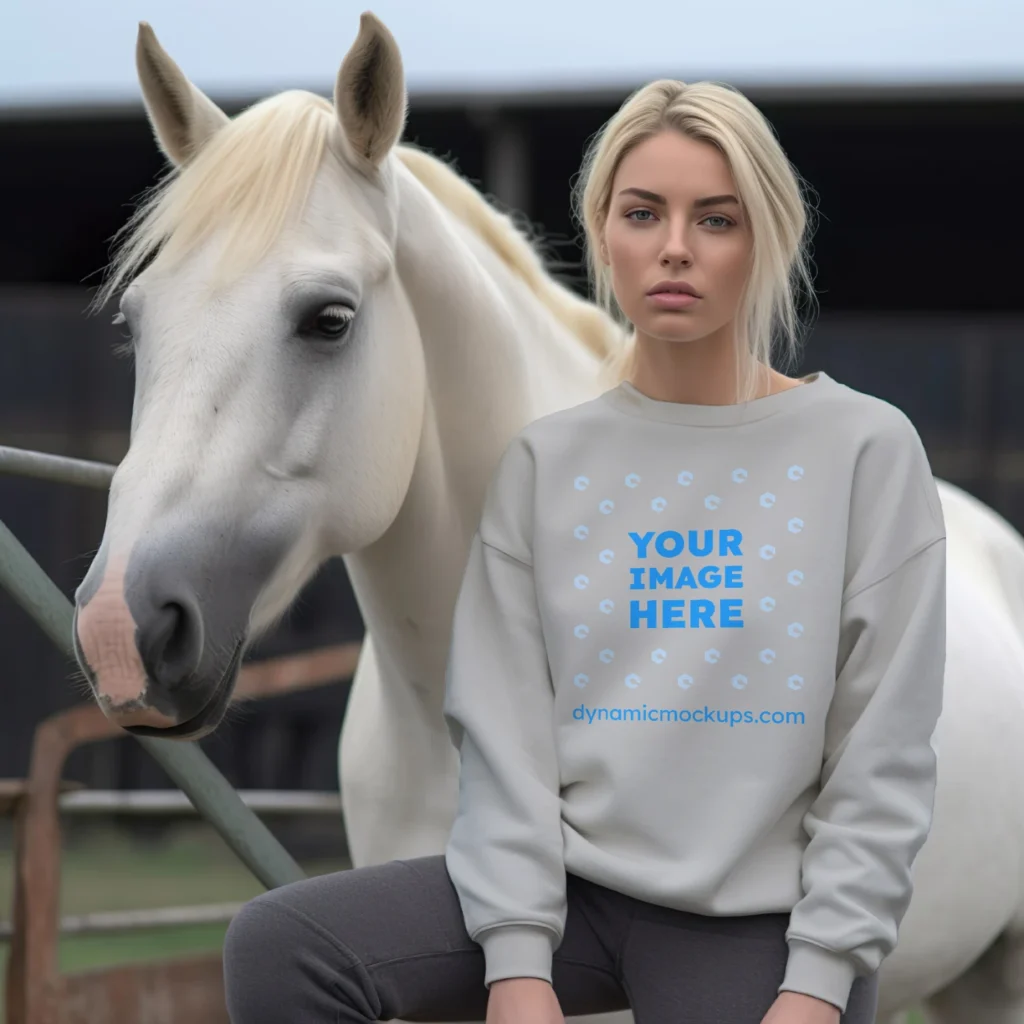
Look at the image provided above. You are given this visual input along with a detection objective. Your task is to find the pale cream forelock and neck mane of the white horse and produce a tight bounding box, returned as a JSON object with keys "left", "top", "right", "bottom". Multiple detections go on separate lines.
{"left": 92, "top": 90, "right": 620, "bottom": 358}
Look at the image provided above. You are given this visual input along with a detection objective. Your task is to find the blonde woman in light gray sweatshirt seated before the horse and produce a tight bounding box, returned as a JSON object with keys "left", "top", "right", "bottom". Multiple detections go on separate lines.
{"left": 225, "top": 81, "right": 945, "bottom": 1024}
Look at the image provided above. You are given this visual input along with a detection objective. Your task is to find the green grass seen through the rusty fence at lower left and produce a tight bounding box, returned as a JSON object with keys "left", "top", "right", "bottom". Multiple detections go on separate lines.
{"left": 0, "top": 824, "right": 349, "bottom": 1020}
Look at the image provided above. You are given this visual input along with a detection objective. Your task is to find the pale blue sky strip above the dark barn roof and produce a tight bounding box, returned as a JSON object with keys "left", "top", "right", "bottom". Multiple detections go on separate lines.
{"left": 0, "top": 0, "right": 1024, "bottom": 109}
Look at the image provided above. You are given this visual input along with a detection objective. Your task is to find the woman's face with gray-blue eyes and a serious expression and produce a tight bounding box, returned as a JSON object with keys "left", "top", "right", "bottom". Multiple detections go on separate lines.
{"left": 601, "top": 130, "right": 753, "bottom": 341}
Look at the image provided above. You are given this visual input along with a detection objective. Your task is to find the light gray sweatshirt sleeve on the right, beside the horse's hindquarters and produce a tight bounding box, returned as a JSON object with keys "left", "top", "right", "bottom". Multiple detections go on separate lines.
{"left": 780, "top": 407, "right": 946, "bottom": 1010}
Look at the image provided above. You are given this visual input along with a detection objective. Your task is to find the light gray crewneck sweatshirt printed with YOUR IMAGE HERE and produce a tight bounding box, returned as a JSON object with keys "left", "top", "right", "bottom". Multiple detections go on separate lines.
{"left": 444, "top": 373, "right": 945, "bottom": 1009}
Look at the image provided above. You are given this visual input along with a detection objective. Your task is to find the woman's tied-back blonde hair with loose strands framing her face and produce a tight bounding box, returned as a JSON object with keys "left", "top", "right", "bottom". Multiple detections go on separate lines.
{"left": 573, "top": 79, "right": 814, "bottom": 401}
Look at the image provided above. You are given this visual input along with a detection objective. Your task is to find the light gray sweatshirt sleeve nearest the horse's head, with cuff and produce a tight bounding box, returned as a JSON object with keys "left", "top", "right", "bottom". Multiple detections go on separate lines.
{"left": 444, "top": 438, "right": 565, "bottom": 986}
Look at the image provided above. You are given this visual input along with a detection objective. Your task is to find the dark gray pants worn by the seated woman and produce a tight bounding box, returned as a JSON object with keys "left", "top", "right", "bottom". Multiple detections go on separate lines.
{"left": 224, "top": 856, "right": 877, "bottom": 1024}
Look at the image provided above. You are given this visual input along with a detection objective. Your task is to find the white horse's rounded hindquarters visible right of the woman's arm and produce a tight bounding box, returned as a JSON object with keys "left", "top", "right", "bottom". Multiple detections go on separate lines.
{"left": 879, "top": 481, "right": 1024, "bottom": 1024}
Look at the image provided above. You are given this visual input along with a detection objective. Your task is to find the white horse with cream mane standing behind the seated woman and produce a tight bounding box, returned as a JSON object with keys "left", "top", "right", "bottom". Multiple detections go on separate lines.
{"left": 77, "top": 14, "right": 1024, "bottom": 1024}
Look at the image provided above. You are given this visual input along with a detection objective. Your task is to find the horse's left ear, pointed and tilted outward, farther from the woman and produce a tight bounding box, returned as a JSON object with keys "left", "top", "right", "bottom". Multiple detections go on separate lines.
{"left": 135, "top": 22, "right": 229, "bottom": 165}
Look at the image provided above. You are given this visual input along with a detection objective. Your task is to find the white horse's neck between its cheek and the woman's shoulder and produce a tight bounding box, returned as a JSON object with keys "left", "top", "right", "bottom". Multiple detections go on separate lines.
{"left": 345, "top": 161, "right": 598, "bottom": 712}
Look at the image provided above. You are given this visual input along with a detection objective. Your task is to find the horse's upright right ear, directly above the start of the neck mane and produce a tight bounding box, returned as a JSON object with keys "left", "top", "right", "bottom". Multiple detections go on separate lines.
{"left": 334, "top": 11, "right": 406, "bottom": 168}
